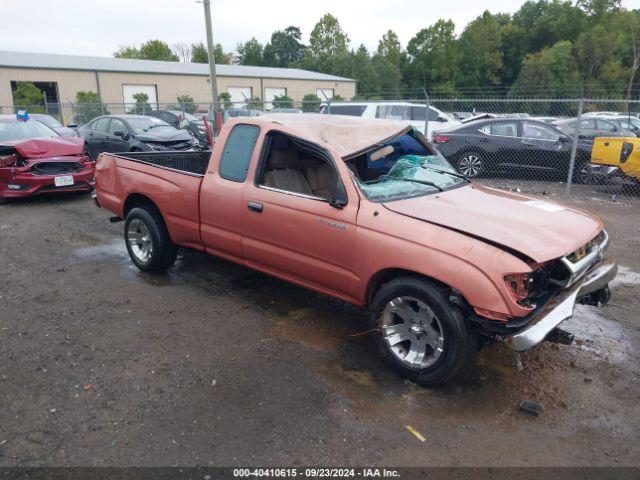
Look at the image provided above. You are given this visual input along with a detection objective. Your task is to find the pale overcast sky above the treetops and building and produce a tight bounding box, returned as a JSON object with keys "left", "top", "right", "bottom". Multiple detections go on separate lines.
{"left": 0, "top": 0, "right": 638, "bottom": 56}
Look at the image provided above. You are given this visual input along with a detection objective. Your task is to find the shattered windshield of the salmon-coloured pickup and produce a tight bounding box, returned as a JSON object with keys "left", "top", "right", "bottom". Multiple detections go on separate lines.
{"left": 354, "top": 132, "right": 469, "bottom": 202}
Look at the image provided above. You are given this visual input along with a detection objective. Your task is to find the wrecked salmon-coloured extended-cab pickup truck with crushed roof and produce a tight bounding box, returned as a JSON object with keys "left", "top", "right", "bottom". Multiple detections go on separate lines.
{"left": 96, "top": 114, "right": 617, "bottom": 385}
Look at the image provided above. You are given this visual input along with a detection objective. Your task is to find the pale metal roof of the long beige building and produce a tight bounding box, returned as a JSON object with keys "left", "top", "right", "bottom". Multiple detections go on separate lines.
{"left": 0, "top": 50, "right": 355, "bottom": 82}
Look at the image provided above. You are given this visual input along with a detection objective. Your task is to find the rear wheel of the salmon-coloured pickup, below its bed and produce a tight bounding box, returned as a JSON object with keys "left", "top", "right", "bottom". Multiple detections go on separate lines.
{"left": 124, "top": 206, "right": 178, "bottom": 273}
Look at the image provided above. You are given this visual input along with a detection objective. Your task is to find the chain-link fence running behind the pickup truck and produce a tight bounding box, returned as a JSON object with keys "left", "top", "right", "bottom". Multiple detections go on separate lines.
{"left": 0, "top": 98, "right": 640, "bottom": 202}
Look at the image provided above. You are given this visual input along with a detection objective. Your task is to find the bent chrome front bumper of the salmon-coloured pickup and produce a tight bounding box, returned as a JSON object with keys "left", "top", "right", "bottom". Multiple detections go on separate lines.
{"left": 503, "top": 260, "right": 618, "bottom": 352}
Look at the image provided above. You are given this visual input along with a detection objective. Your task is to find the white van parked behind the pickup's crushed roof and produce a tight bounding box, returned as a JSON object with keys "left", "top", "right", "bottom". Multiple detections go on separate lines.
{"left": 322, "top": 102, "right": 460, "bottom": 138}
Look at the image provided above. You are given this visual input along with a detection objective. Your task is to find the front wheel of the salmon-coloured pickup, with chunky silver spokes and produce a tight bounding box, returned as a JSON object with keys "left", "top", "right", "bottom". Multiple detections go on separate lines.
{"left": 370, "top": 277, "right": 474, "bottom": 386}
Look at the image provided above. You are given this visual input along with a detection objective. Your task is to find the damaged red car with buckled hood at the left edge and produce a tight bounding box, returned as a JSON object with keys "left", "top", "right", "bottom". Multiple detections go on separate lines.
{"left": 0, "top": 115, "right": 95, "bottom": 202}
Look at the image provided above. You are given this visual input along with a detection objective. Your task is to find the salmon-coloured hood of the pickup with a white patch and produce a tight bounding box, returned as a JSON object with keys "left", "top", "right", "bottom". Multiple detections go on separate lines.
{"left": 384, "top": 184, "right": 602, "bottom": 263}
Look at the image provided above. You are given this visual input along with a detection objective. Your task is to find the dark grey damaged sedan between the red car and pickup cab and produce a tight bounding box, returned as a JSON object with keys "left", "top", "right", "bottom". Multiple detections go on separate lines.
{"left": 78, "top": 115, "right": 201, "bottom": 159}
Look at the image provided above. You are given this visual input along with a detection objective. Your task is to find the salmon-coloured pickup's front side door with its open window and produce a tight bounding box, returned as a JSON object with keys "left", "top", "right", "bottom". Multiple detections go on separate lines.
{"left": 242, "top": 131, "right": 359, "bottom": 298}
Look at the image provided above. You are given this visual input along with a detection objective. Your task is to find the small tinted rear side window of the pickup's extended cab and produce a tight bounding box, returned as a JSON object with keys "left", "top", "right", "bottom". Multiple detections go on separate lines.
{"left": 220, "top": 125, "right": 260, "bottom": 182}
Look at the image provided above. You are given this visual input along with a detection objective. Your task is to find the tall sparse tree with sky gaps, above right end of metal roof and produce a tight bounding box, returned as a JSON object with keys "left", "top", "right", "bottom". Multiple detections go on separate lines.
{"left": 302, "top": 13, "right": 349, "bottom": 73}
